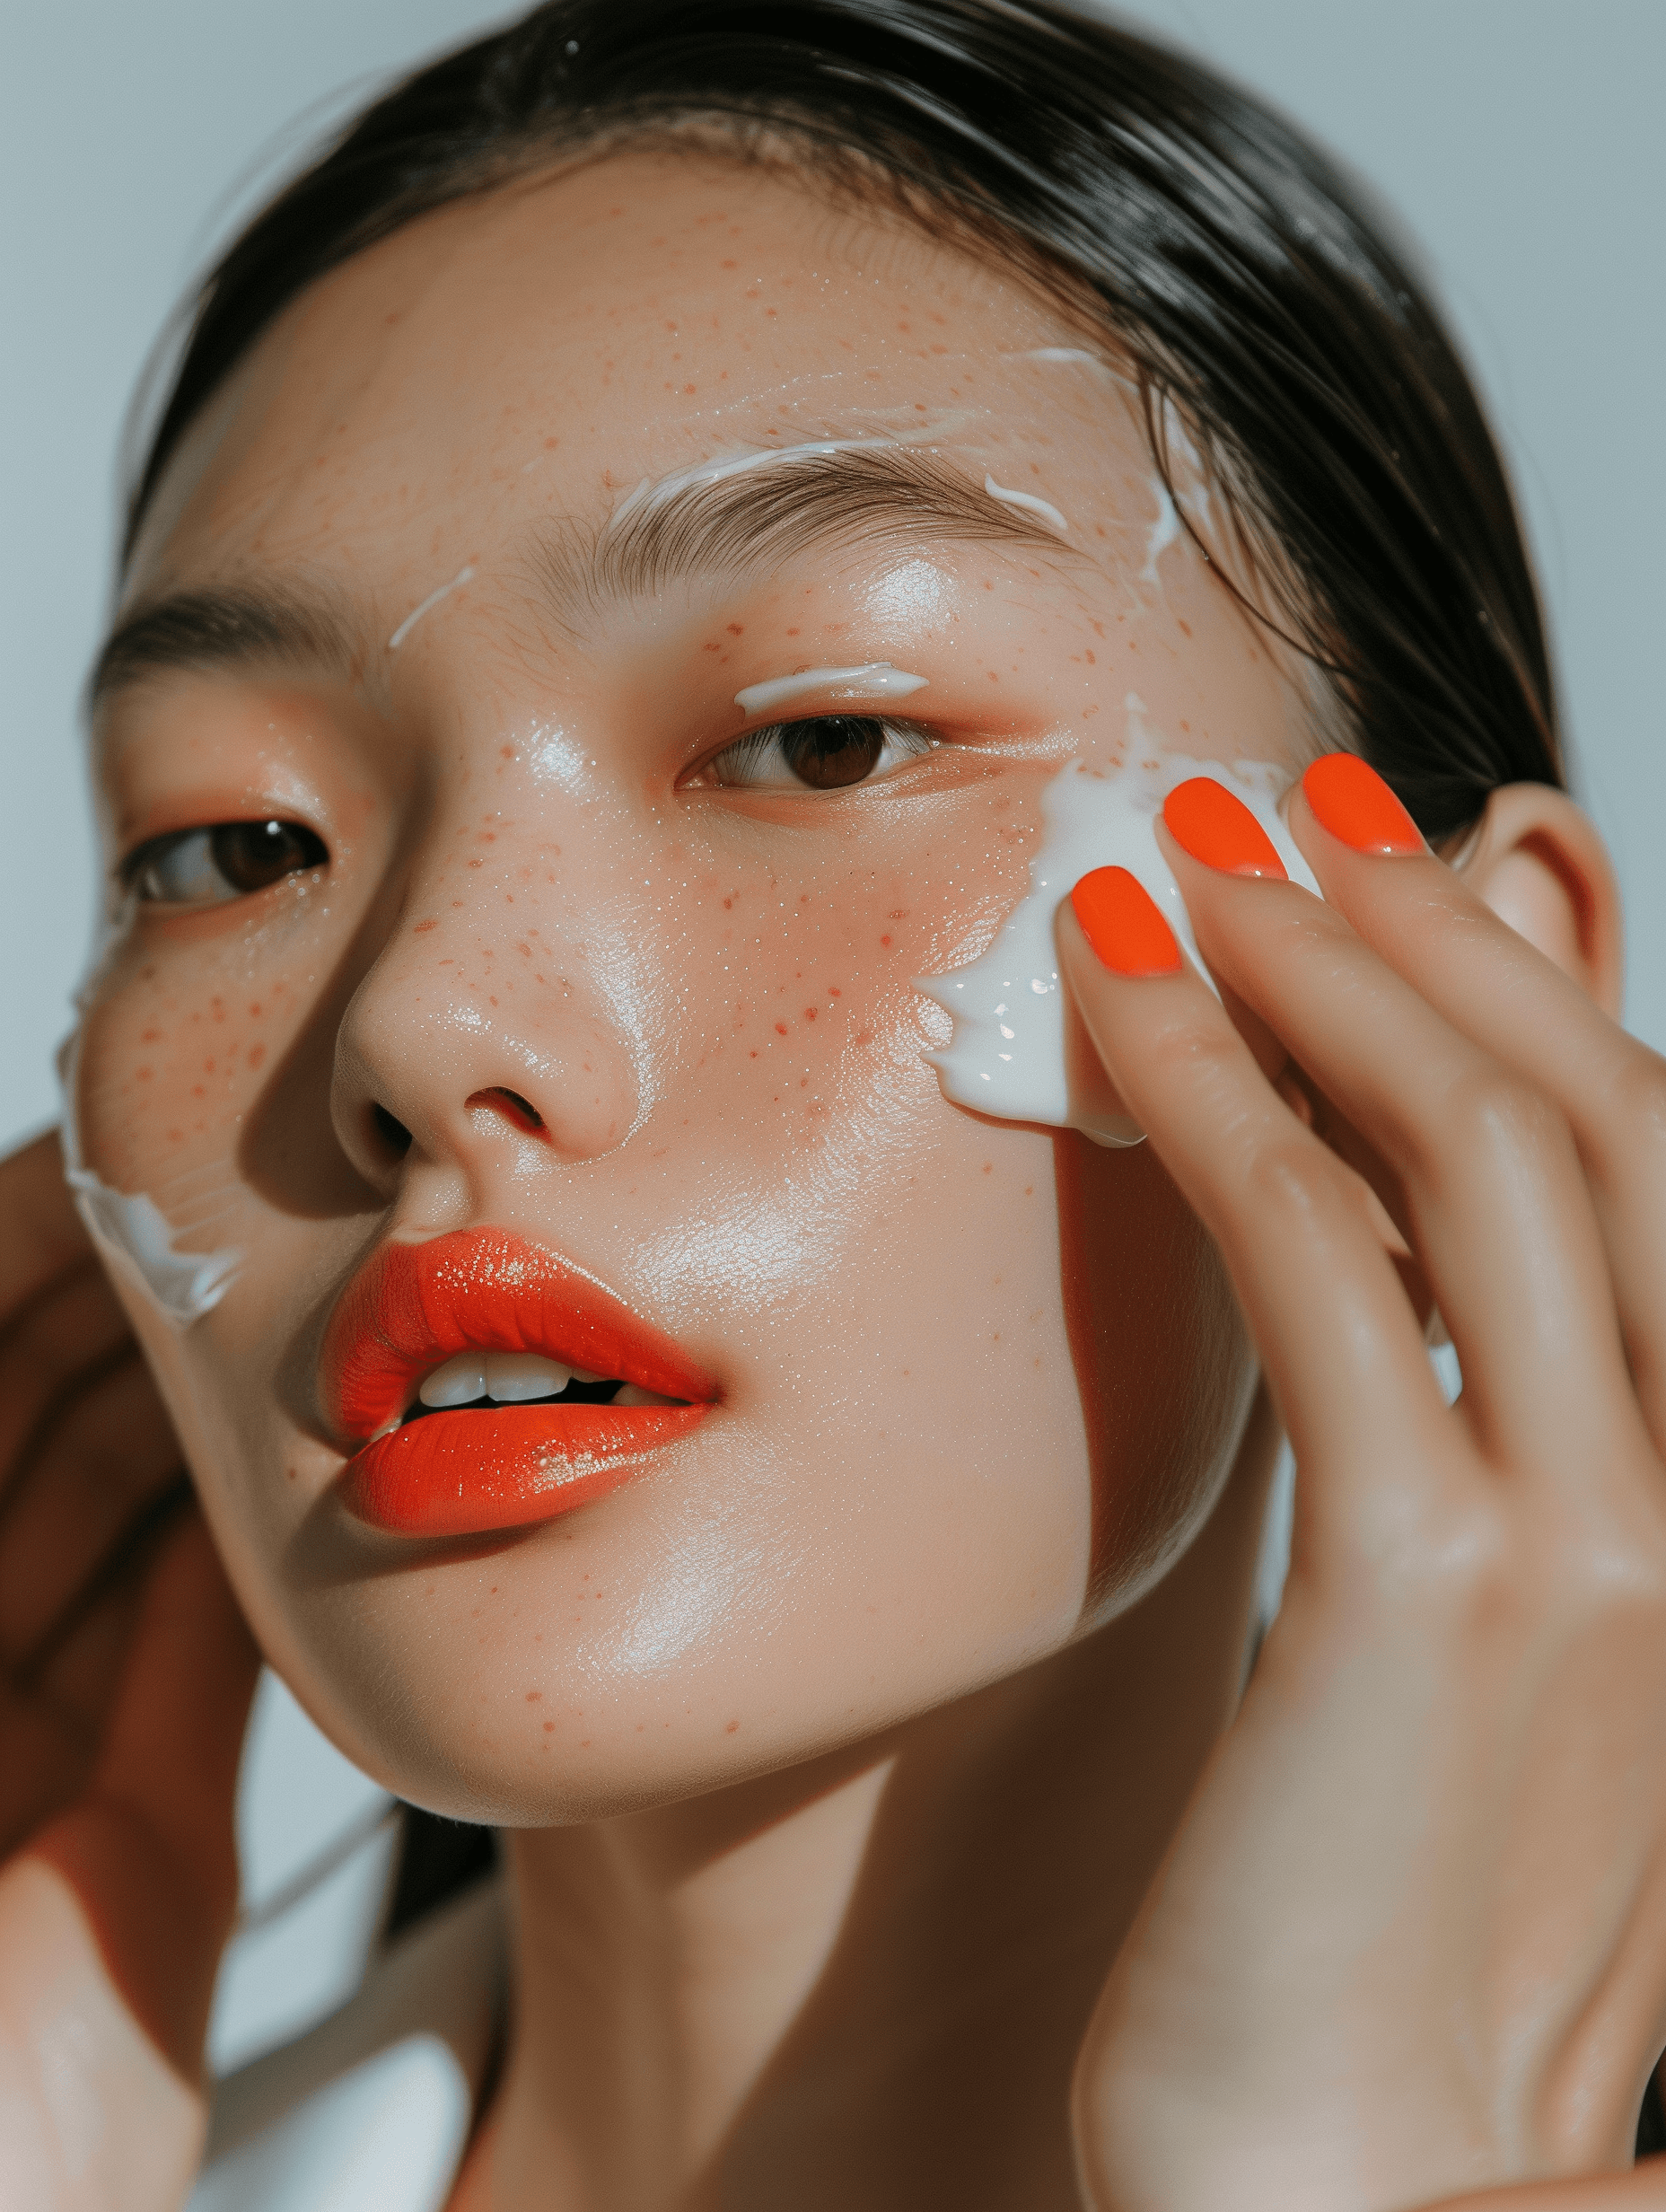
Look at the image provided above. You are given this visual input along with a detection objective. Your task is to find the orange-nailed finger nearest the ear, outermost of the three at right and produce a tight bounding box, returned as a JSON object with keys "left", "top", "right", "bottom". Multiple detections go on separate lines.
{"left": 1290, "top": 761, "right": 1666, "bottom": 1451}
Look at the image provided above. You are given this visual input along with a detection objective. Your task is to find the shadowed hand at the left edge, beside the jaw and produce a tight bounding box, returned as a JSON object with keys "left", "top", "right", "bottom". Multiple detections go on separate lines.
{"left": 0, "top": 1137, "right": 257, "bottom": 2212}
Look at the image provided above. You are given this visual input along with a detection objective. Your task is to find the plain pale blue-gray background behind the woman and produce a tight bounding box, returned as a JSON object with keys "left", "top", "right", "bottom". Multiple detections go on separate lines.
{"left": 0, "top": 0, "right": 1666, "bottom": 2066}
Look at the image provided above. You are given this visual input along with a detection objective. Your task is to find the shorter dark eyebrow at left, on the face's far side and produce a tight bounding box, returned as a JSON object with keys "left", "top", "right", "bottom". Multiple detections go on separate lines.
{"left": 86, "top": 586, "right": 358, "bottom": 712}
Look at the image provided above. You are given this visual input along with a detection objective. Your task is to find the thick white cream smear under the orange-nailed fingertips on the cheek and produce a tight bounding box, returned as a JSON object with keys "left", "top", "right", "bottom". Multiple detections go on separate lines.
{"left": 914, "top": 751, "right": 1319, "bottom": 1146}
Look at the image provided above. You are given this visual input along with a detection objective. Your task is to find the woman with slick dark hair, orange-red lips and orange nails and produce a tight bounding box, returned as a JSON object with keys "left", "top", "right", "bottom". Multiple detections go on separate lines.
{"left": 0, "top": 0, "right": 1666, "bottom": 2212}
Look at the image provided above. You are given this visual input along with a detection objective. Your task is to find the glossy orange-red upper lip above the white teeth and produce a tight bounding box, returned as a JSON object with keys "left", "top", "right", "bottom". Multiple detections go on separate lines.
{"left": 320, "top": 1228, "right": 717, "bottom": 1443}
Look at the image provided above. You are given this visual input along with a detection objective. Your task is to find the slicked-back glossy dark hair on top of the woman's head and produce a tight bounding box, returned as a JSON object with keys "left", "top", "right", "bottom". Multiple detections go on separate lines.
{"left": 128, "top": 0, "right": 1562, "bottom": 838}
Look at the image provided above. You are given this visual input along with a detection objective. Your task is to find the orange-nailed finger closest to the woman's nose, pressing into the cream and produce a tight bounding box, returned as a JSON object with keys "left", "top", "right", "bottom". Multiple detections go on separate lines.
{"left": 1057, "top": 869, "right": 1449, "bottom": 1513}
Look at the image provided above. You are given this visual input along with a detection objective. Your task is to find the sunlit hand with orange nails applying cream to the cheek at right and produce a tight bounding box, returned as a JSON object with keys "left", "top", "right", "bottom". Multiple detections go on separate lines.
{"left": 1060, "top": 772, "right": 1666, "bottom": 2212}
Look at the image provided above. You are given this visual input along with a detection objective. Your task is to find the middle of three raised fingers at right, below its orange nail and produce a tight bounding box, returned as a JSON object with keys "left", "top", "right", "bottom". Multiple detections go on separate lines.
{"left": 1162, "top": 786, "right": 1648, "bottom": 1479}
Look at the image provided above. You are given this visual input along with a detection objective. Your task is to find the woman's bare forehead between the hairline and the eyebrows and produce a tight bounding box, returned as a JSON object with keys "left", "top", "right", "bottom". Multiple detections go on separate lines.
{"left": 130, "top": 153, "right": 1151, "bottom": 595}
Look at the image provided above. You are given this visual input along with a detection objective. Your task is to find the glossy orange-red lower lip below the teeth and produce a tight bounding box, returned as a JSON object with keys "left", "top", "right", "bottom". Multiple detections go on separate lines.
{"left": 343, "top": 1405, "right": 708, "bottom": 1535}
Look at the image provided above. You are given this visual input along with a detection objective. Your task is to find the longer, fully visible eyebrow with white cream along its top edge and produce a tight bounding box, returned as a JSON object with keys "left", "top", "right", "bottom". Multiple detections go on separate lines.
{"left": 535, "top": 447, "right": 1082, "bottom": 621}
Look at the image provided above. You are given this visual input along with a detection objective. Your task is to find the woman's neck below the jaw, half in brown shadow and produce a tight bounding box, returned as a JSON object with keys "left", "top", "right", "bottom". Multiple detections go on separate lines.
{"left": 469, "top": 1418, "right": 1272, "bottom": 2212}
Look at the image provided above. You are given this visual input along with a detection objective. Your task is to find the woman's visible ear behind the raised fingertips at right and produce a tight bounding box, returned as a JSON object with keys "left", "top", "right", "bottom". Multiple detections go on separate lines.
{"left": 1453, "top": 783, "right": 1624, "bottom": 1020}
